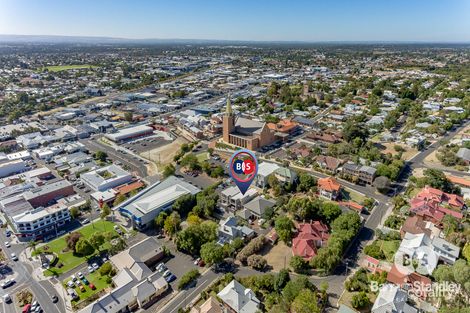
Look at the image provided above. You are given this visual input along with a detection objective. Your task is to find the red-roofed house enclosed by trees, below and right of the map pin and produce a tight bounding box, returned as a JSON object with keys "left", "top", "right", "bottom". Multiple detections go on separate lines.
{"left": 292, "top": 221, "right": 329, "bottom": 261}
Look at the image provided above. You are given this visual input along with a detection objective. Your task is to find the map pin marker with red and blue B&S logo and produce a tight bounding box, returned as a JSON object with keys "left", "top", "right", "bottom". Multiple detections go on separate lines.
{"left": 230, "top": 150, "right": 258, "bottom": 194}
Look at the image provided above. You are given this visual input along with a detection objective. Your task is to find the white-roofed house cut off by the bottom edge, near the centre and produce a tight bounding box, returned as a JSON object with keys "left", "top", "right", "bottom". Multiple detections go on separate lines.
{"left": 217, "top": 279, "right": 261, "bottom": 313}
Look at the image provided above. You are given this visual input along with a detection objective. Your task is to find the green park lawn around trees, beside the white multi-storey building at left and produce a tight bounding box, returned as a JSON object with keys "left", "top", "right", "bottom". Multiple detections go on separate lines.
{"left": 34, "top": 221, "right": 122, "bottom": 276}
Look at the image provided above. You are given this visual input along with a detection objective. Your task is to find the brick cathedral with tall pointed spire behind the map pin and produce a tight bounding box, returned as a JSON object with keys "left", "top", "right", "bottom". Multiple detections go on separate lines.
{"left": 222, "top": 98, "right": 276, "bottom": 150}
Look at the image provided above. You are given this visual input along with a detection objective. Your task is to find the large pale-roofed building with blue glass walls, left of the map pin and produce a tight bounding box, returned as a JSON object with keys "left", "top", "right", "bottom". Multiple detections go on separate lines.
{"left": 114, "top": 176, "right": 201, "bottom": 230}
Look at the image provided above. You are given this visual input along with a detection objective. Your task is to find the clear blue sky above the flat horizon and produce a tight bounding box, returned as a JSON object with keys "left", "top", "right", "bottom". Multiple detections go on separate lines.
{"left": 0, "top": 0, "right": 470, "bottom": 42}
